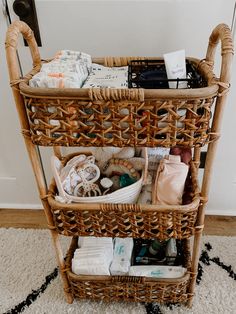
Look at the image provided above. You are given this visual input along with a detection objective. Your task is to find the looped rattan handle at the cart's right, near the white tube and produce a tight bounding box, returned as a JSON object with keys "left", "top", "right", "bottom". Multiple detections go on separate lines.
{"left": 206, "top": 24, "right": 234, "bottom": 83}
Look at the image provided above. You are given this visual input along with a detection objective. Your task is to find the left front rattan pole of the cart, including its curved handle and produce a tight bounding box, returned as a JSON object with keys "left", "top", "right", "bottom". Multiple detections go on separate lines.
{"left": 6, "top": 21, "right": 73, "bottom": 303}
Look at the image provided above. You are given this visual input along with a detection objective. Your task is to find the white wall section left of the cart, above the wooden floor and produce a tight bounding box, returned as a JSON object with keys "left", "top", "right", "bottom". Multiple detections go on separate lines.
{"left": 0, "top": 10, "right": 41, "bottom": 208}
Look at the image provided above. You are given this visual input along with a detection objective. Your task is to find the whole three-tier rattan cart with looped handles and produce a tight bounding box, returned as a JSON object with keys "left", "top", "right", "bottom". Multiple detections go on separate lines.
{"left": 6, "top": 21, "right": 233, "bottom": 306}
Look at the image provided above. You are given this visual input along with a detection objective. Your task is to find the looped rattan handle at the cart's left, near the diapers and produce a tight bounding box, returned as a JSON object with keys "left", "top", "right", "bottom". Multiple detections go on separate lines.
{"left": 5, "top": 21, "right": 41, "bottom": 81}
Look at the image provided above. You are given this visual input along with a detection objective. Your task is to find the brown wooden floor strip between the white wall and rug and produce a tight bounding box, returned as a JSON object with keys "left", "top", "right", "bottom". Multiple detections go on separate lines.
{"left": 0, "top": 209, "right": 236, "bottom": 236}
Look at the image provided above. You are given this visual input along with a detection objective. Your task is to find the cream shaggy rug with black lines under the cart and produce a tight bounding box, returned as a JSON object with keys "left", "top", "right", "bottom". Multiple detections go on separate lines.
{"left": 0, "top": 228, "right": 236, "bottom": 314}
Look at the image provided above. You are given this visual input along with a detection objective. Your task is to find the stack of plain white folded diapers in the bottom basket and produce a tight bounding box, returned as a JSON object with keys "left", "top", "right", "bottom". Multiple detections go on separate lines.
{"left": 72, "top": 237, "right": 113, "bottom": 275}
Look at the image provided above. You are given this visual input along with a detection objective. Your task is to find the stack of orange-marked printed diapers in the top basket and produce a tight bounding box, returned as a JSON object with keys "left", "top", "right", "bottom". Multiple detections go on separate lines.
{"left": 29, "top": 50, "right": 92, "bottom": 88}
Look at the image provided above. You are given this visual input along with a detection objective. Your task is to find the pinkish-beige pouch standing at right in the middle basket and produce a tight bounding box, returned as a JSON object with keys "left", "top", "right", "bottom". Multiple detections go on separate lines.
{"left": 152, "top": 155, "right": 189, "bottom": 205}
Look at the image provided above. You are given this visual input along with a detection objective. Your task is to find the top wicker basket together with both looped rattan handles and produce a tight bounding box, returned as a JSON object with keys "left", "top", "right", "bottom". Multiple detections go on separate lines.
{"left": 6, "top": 21, "right": 233, "bottom": 147}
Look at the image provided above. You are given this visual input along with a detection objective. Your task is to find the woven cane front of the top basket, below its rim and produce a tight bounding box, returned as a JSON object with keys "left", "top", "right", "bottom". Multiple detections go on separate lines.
{"left": 25, "top": 97, "right": 214, "bottom": 147}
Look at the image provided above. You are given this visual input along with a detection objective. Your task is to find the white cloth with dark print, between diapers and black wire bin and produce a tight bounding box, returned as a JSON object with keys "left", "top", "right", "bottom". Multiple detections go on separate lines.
{"left": 83, "top": 63, "right": 128, "bottom": 88}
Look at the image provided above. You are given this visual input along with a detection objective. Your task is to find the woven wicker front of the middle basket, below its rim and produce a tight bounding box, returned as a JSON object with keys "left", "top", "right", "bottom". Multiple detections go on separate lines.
{"left": 50, "top": 204, "right": 198, "bottom": 240}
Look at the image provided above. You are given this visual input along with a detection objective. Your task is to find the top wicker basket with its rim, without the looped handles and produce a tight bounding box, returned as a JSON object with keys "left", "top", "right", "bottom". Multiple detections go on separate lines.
{"left": 20, "top": 58, "right": 219, "bottom": 147}
